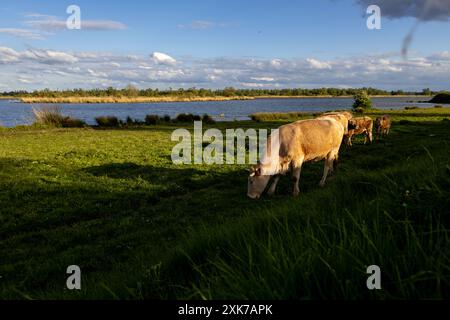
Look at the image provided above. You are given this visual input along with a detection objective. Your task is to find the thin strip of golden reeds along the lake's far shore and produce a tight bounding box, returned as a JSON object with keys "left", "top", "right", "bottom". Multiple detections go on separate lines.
{"left": 6, "top": 95, "right": 425, "bottom": 104}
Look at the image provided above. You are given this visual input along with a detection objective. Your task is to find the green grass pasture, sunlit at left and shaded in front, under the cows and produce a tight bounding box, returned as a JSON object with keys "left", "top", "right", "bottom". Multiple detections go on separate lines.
{"left": 0, "top": 114, "right": 450, "bottom": 299}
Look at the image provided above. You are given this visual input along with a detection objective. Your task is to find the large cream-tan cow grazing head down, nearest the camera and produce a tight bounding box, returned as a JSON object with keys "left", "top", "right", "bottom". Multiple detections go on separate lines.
{"left": 247, "top": 118, "right": 344, "bottom": 199}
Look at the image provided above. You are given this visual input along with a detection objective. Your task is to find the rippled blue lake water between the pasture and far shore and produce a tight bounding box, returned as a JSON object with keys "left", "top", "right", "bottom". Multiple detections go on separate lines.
{"left": 0, "top": 97, "right": 442, "bottom": 127}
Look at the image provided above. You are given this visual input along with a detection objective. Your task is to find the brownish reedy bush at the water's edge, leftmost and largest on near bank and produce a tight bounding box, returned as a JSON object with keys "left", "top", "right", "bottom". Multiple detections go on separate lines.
{"left": 33, "top": 106, "right": 86, "bottom": 128}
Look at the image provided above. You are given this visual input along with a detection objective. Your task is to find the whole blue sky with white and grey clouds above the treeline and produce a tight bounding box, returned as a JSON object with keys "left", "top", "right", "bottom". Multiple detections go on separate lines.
{"left": 0, "top": 0, "right": 450, "bottom": 91}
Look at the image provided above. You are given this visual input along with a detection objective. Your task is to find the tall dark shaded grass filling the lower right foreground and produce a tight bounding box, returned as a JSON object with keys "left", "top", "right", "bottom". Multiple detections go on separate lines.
{"left": 144, "top": 141, "right": 450, "bottom": 299}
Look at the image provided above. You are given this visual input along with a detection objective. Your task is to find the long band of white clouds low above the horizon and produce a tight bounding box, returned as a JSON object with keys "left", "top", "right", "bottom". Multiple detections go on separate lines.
{"left": 0, "top": 47, "right": 450, "bottom": 91}
